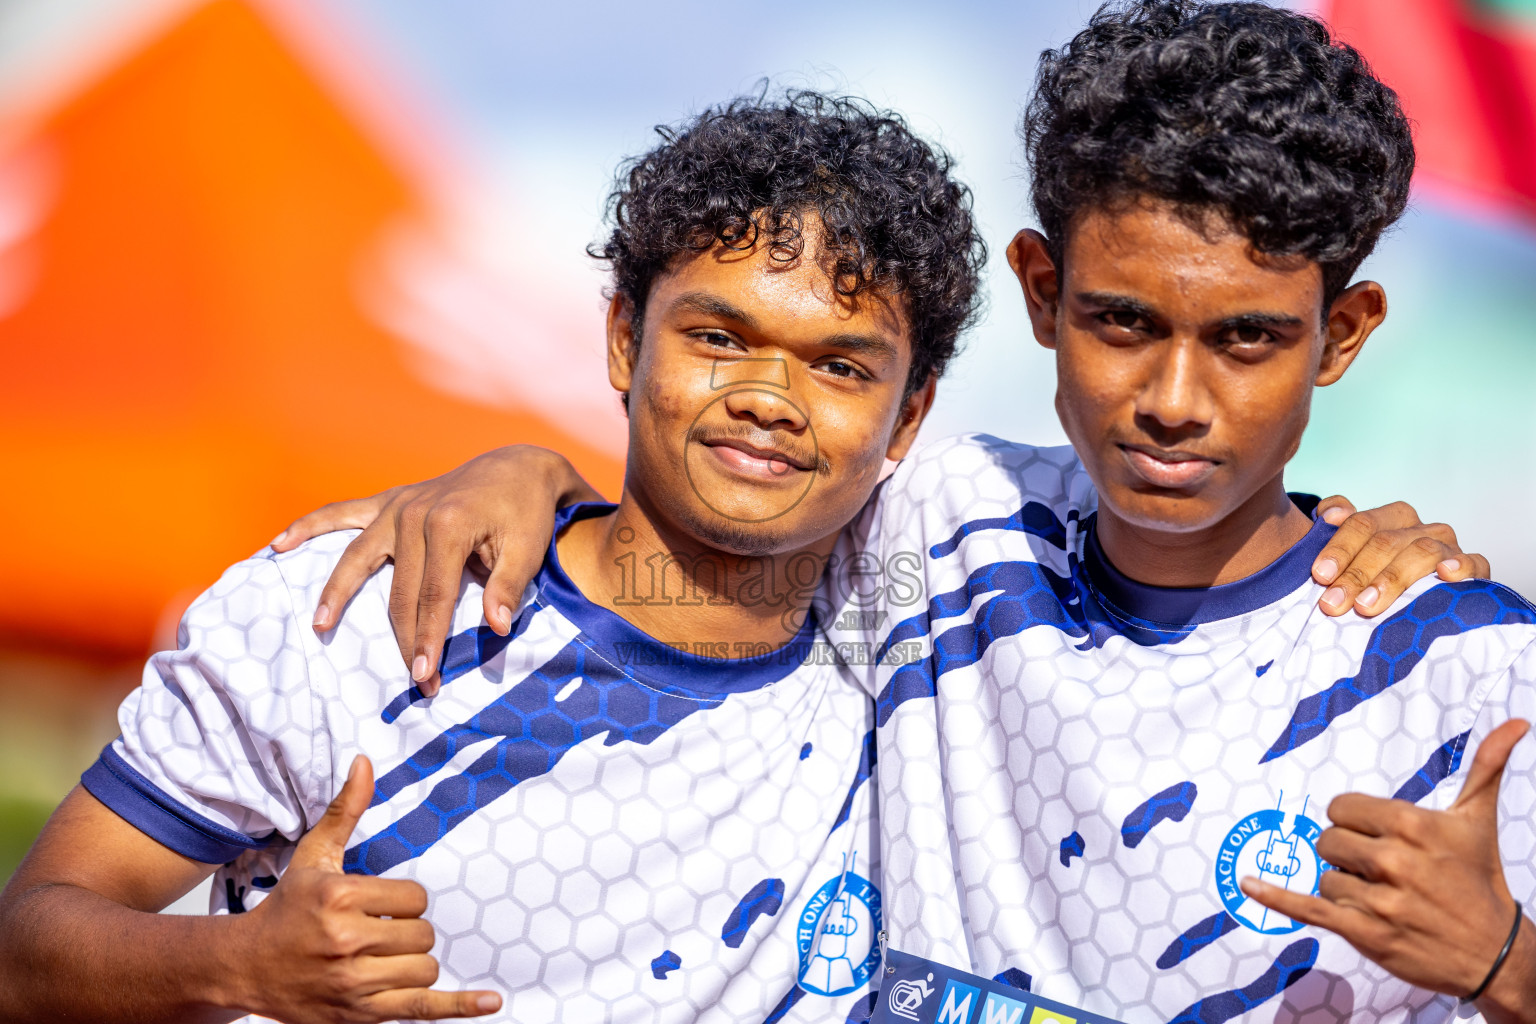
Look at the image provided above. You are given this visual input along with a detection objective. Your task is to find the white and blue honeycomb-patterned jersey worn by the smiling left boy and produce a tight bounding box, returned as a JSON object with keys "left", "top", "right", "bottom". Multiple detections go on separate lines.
{"left": 83, "top": 505, "right": 880, "bottom": 1024}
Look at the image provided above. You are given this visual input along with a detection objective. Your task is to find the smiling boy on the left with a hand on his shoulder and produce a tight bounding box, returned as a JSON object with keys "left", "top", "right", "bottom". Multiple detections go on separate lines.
{"left": 0, "top": 94, "right": 985, "bottom": 1022}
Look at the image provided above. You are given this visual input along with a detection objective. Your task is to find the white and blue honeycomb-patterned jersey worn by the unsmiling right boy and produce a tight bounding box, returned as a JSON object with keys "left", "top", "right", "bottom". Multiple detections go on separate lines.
{"left": 828, "top": 436, "right": 1536, "bottom": 1024}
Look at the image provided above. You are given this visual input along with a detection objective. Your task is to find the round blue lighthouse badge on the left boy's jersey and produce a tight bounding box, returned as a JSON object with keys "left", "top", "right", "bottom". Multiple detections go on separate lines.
{"left": 797, "top": 861, "right": 880, "bottom": 995}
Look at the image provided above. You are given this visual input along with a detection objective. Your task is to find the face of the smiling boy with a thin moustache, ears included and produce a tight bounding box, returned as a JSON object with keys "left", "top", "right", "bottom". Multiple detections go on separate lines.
{"left": 608, "top": 216, "right": 932, "bottom": 554}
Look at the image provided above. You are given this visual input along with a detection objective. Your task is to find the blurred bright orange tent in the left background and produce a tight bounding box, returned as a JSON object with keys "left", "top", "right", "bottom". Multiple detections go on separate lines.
{"left": 0, "top": 0, "right": 621, "bottom": 656}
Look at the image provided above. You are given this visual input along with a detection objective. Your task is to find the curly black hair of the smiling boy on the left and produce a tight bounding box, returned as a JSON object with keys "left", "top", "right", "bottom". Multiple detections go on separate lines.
{"left": 588, "top": 88, "right": 986, "bottom": 395}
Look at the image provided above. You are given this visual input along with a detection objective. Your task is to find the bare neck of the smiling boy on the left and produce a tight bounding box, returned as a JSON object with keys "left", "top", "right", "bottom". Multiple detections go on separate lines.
{"left": 556, "top": 490, "right": 837, "bottom": 657}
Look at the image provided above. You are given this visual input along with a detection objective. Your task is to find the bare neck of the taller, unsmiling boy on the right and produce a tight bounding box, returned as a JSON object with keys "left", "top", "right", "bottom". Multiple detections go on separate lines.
{"left": 1097, "top": 477, "right": 1312, "bottom": 586}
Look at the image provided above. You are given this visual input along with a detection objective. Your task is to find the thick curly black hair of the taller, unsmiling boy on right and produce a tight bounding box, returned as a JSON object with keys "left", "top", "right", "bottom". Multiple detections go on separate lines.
{"left": 1020, "top": 0, "right": 1413, "bottom": 303}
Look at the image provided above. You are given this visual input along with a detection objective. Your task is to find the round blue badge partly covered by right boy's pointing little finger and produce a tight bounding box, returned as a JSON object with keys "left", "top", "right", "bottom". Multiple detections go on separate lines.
{"left": 1217, "top": 794, "right": 1324, "bottom": 935}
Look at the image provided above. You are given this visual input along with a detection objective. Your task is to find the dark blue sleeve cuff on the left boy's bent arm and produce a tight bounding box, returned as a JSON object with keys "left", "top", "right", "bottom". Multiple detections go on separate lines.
{"left": 80, "top": 746, "right": 272, "bottom": 864}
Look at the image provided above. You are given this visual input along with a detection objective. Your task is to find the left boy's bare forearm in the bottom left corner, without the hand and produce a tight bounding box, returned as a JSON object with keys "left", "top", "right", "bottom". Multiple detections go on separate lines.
{"left": 0, "top": 884, "right": 255, "bottom": 1024}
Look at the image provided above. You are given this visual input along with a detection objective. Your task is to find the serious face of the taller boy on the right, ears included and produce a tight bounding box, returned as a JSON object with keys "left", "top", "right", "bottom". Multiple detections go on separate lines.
{"left": 1009, "top": 201, "right": 1385, "bottom": 533}
